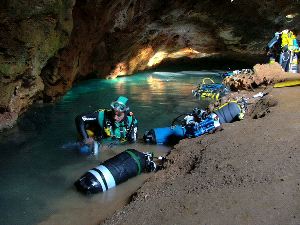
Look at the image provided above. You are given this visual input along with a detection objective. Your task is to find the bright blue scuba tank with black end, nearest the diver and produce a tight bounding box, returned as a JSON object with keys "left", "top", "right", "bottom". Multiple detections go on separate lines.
{"left": 143, "top": 125, "right": 185, "bottom": 144}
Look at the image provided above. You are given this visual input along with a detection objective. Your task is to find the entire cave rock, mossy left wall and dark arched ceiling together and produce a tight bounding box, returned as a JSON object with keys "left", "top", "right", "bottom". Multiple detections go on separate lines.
{"left": 0, "top": 0, "right": 300, "bottom": 130}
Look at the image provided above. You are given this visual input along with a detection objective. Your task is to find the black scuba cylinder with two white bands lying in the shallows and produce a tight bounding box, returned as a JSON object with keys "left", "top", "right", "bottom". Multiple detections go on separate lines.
{"left": 74, "top": 149, "right": 146, "bottom": 194}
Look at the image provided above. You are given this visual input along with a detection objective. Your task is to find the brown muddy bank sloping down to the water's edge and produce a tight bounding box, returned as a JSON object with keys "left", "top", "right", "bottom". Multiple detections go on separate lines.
{"left": 104, "top": 87, "right": 300, "bottom": 225}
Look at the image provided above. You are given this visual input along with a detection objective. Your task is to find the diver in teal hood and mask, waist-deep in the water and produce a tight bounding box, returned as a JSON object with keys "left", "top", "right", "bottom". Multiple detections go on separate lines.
{"left": 75, "top": 96, "right": 138, "bottom": 145}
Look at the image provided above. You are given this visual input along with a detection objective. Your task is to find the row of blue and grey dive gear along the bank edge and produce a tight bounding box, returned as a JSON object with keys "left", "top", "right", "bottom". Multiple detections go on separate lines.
{"left": 143, "top": 98, "right": 247, "bottom": 144}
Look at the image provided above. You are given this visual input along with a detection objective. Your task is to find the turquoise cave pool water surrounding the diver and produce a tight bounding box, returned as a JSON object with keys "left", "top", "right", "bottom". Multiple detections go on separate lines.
{"left": 0, "top": 71, "right": 221, "bottom": 225}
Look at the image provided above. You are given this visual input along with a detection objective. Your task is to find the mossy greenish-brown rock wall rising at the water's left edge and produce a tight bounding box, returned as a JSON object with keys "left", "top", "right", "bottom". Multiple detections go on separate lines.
{"left": 0, "top": 0, "right": 74, "bottom": 130}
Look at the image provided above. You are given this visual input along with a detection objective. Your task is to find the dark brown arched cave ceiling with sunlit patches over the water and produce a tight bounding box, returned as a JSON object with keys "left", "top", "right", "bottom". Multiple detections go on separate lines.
{"left": 42, "top": 0, "right": 299, "bottom": 99}
